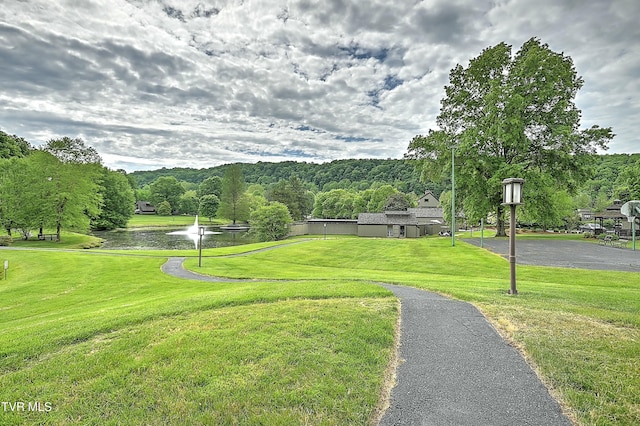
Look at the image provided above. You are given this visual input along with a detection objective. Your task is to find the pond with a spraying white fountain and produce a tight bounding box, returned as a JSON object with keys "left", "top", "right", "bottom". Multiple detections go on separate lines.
{"left": 93, "top": 226, "right": 256, "bottom": 250}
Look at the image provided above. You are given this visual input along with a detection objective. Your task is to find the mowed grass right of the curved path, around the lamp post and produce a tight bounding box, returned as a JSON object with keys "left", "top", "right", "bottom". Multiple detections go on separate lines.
{"left": 186, "top": 237, "right": 640, "bottom": 425}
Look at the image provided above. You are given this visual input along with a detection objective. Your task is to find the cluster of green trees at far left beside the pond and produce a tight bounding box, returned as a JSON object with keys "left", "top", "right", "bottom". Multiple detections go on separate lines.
{"left": 0, "top": 131, "right": 135, "bottom": 240}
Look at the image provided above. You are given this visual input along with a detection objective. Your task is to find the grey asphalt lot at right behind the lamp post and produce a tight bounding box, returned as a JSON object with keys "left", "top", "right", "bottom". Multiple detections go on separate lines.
{"left": 464, "top": 237, "right": 640, "bottom": 272}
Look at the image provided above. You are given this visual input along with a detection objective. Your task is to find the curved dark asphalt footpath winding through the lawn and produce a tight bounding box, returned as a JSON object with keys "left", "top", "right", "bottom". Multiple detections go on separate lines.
{"left": 162, "top": 251, "right": 571, "bottom": 426}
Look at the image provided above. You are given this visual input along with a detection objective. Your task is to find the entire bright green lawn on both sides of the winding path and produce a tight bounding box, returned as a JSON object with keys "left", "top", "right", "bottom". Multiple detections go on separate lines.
{"left": 0, "top": 238, "right": 640, "bottom": 425}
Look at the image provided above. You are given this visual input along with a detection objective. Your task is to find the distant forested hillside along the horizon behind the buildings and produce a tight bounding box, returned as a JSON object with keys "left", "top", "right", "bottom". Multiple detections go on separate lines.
{"left": 129, "top": 154, "right": 640, "bottom": 210}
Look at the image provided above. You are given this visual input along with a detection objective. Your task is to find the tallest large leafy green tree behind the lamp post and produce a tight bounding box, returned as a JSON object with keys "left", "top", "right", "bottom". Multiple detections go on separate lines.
{"left": 406, "top": 38, "right": 613, "bottom": 235}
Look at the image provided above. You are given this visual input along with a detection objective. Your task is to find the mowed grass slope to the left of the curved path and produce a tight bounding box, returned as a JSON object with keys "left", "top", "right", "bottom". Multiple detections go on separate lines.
{"left": 0, "top": 248, "right": 398, "bottom": 425}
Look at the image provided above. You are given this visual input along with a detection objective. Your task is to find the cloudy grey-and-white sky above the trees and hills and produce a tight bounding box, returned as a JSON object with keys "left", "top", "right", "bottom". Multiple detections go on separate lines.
{"left": 0, "top": 0, "right": 640, "bottom": 171}
